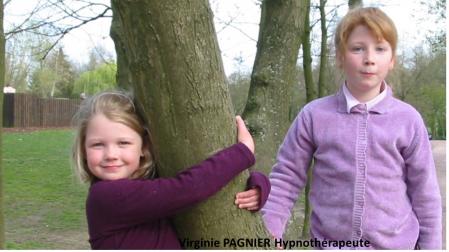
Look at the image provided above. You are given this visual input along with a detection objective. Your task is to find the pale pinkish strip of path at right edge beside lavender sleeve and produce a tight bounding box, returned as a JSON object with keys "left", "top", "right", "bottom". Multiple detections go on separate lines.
{"left": 431, "top": 140, "right": 446, "bottom": 249}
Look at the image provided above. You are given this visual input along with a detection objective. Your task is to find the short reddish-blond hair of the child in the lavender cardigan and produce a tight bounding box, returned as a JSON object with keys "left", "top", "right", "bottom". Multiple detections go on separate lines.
{"left": 334, "top": 7, "right": 398, "bottom": 58}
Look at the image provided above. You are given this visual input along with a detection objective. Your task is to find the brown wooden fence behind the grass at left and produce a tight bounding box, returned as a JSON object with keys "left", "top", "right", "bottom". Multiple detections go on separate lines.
{"left": 3, "top": 94, "right": 81, "bottom": 128}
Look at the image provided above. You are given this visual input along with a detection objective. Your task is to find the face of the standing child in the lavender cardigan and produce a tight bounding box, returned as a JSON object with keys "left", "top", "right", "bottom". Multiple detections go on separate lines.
{"left": 339, "top": 25, "right": 394, "bottom": 102}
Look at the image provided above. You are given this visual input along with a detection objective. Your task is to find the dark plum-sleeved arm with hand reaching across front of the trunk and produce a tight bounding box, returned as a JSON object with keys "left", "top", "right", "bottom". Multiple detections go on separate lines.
{"left": 86, "top": 116, "right": 255, "bottom": 229}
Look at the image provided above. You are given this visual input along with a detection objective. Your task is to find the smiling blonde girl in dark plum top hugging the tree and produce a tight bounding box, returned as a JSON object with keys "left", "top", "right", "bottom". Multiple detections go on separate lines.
{"left": 73, "top": 91, "right": 270, "bottom": 249}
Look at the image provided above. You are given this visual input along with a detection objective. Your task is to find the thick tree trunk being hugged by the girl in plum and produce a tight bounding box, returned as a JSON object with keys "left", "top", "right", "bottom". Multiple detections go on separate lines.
{"left": 111, "top": 0, "right": 267, "bottom": 248}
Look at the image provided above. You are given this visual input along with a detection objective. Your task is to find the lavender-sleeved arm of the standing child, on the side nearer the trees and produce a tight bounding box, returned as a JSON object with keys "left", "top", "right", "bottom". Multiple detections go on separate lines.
{"left": 262, "top": 110, "right": 315, "bottom": 238}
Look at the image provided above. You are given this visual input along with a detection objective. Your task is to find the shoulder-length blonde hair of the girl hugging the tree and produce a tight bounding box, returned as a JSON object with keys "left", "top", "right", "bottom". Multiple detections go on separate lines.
{"left": 72, "top": 91, "right": 155, "bottom": 183}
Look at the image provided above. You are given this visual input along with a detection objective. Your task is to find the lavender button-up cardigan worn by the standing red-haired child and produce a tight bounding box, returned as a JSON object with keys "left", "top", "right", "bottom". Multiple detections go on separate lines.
{"left": 262, "top": 87, "right": 442, "bottom": 249}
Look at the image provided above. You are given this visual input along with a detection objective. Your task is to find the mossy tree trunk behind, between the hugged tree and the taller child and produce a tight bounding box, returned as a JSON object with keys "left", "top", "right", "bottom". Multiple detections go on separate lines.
{"left": 243, "top": 0, "right": 304, "bottom": 239}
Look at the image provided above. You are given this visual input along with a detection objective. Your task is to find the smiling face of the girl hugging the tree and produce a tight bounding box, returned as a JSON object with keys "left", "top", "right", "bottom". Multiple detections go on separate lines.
{"left": 85, "top": 114, "right": 143, "bottom": 180}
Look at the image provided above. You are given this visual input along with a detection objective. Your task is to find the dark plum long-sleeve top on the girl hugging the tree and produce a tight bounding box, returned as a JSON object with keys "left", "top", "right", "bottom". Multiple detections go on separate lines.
{"left": 86, "top": 143, "right": 270, "bottom": 249}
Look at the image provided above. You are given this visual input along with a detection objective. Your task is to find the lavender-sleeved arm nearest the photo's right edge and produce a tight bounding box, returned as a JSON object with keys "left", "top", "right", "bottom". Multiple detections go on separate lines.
{"left": 404, "top": 118, "right": 442, "bottom": 249}
